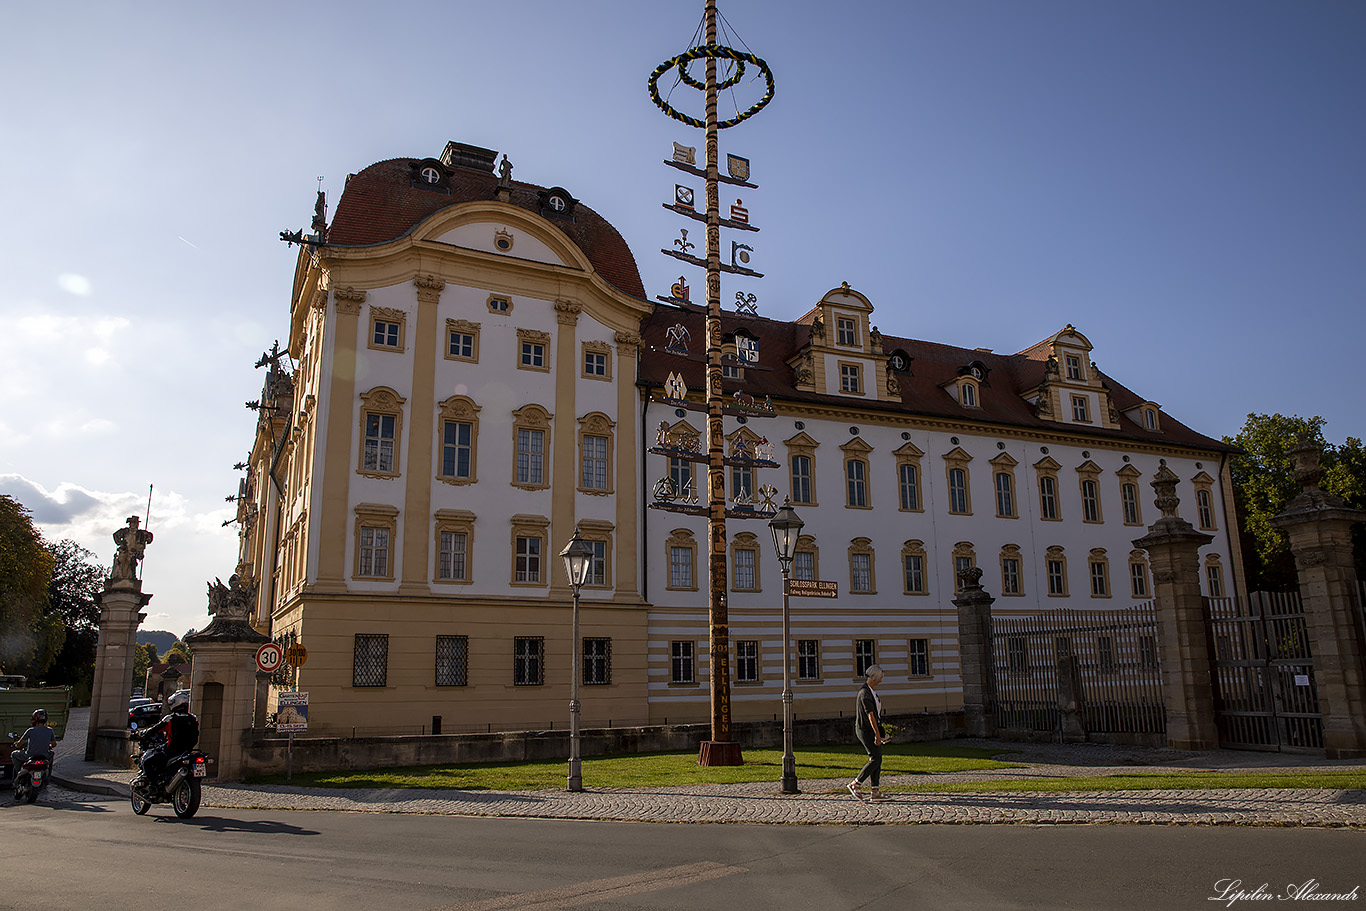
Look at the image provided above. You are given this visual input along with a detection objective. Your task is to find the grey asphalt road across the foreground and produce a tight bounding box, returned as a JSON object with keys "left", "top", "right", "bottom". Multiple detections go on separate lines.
{"left": 0, "top": 791, "right": 1366, "bottom": 911}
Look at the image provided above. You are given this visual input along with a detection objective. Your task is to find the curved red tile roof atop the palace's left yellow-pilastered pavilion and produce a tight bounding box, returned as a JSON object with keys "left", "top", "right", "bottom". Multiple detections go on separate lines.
{"left": 328, "top": 158, "right": 645, "bottom": 299}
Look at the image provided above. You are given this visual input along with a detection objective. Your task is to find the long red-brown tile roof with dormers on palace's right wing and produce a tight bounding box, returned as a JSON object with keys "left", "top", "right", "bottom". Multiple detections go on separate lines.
{"left": 639, "top": 303, "right": 1236, "bottom": 452}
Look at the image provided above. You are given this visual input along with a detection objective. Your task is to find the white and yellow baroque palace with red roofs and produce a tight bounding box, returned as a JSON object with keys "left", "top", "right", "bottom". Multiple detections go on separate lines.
{"left": 238, "top": 142, "right": 1242, "bottom": 733}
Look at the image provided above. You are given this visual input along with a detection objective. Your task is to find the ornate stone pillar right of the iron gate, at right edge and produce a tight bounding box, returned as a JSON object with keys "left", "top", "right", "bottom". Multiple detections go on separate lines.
{"left": 1272, "top": 441, "right": 1366, "bottom": 759}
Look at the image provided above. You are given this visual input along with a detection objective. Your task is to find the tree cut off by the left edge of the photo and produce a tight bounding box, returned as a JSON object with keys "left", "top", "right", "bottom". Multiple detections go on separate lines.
{"left": 0, "top": 494, "right": 61, "bottom": 676}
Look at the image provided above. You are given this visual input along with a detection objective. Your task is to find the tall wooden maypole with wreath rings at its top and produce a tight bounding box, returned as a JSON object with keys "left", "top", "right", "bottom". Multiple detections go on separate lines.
{"left": 649, "top": 0, "right": 773, "bottom": 765}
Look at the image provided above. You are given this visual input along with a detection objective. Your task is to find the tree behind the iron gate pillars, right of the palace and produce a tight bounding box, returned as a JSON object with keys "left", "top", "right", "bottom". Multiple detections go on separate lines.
{"left": 1224, "top": 414, "right": 1366, "bottom": 591}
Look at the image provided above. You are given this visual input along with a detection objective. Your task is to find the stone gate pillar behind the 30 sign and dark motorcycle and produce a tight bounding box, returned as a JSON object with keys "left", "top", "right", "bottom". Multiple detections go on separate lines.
{"left": 184, "top": 575, "right": 270, "bottom": 779}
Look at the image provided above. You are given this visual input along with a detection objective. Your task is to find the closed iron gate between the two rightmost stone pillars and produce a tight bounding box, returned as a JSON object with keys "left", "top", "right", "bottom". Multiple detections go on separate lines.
{"left": 1205, "top": 591, "right": 1324, "bottom": 753}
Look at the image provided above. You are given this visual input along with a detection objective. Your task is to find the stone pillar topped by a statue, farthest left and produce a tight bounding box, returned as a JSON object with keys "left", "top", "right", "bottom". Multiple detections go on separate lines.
{"left": 85, "top": 516, "right": 152, "bottom": 766}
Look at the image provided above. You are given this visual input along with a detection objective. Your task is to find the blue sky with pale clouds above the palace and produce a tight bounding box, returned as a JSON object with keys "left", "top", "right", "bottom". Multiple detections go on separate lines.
{"left": 0, "top": 0, "right": 1366, "bottom": 641}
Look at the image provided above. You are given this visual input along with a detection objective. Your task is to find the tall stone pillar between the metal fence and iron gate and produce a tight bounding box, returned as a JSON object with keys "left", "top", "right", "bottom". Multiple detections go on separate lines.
{"left": 1134, "top": 464, "right": 1218, "bottom": 750}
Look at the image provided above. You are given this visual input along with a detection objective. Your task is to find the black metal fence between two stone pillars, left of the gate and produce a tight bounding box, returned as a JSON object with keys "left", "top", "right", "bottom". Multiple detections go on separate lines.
{"left": 992, "top": 602, "right": 1167, "bottom": 735}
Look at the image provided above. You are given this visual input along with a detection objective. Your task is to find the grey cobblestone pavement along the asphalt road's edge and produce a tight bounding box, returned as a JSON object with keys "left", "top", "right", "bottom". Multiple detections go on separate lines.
{"left": 45, "top": 720, "right": 1366, "bottom": 828}
